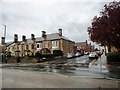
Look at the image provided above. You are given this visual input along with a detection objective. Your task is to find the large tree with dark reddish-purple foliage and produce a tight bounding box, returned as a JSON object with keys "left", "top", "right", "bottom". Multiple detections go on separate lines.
{"left": 88, "top": 1, "right": 120, "bottom": 51}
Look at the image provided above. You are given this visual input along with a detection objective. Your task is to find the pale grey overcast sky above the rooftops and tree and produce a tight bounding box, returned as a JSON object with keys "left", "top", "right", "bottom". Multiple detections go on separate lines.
{"left": 0, "top": 0, "right": 118, "bottom": 42}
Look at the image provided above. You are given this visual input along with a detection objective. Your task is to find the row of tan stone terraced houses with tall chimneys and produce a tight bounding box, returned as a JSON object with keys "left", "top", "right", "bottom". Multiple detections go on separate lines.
{"left": 1, "top": 29, "right": 75, "bottom": 57}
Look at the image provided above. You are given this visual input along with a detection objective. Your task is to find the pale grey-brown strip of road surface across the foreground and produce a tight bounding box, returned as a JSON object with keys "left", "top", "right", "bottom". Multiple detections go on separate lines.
{"left": 0, "top": 69, "right": 119, "bottom": 88}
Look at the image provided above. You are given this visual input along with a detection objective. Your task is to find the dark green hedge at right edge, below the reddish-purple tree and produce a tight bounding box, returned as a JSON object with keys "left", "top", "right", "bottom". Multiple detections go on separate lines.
{"left": 107, "top": 52, "right": 120, "bottom": 62}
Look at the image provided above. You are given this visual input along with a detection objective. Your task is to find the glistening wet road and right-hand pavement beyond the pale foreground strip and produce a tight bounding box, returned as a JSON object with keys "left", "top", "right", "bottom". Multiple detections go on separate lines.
{"left": 1, "top": 55, "right": 120, "bottom": 79}
